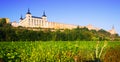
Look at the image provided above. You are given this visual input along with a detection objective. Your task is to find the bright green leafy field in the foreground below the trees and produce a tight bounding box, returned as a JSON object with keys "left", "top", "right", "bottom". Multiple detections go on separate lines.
{"left": 0, "top": 41, "right": 120, "bottom": 62}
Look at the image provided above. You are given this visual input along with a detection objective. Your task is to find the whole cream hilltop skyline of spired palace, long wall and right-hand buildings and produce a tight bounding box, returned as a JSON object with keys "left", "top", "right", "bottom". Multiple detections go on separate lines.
{"left": 12, "top": 9, "right": 116, "bottom": 34}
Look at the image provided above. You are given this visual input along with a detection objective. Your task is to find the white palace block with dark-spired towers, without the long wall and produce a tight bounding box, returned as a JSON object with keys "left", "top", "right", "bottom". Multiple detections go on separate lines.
{"left": 19, "top": 10, "right": 48, "bottom": 28}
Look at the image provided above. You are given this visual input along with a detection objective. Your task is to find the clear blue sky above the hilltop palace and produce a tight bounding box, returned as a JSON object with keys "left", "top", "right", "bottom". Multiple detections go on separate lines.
{"left": 0, "top": 0, "right": 120, "bottom": 34}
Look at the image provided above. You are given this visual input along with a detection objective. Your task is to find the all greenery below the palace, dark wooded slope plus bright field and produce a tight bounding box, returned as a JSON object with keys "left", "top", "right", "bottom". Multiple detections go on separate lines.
{"left": 0, "top": 19, "right": 120, "bottom": 62}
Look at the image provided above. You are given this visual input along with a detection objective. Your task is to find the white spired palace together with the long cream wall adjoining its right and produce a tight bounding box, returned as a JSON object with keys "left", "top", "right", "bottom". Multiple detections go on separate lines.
{"left": 13, "top": 9, "right": 77, "bottom": 29}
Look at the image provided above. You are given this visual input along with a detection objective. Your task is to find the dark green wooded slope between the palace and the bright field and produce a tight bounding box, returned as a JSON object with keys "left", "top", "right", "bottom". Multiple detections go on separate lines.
{"left": 0, "top": 19, "right": 120, "bottom": 41}
